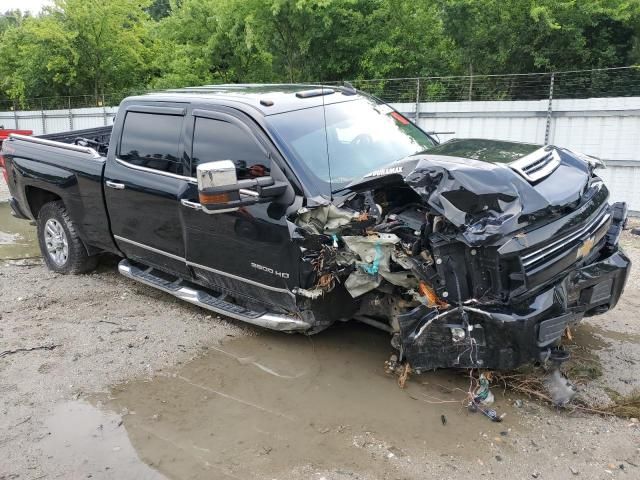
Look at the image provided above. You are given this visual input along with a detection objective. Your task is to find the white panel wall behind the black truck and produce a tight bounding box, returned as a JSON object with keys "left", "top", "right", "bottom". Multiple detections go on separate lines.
{"left": 0, "top": 97, "right": 640, "bottom": 212}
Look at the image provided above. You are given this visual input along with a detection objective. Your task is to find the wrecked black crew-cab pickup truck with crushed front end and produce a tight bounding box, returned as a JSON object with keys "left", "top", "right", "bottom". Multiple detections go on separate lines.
{"left": 2, "top": 85, "right": 630, "bottom": 371}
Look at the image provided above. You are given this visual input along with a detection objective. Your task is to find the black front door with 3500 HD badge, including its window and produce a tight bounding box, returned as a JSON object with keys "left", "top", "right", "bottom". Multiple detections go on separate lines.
{"left": 184, "top": 110, "right": 299, "bottom": 308}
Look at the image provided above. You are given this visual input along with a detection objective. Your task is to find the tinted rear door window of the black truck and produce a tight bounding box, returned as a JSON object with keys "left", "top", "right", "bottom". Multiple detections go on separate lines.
{"left": 119, "top": 112, "right": 184, "bottom": 175}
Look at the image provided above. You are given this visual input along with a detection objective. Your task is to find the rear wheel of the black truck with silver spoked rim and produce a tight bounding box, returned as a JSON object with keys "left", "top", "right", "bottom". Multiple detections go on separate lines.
{"left": 37, "top": 201, "right": 98, "bottom": 274}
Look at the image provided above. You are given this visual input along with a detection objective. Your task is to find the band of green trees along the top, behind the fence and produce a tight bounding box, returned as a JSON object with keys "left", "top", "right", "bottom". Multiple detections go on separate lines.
{"left": 0, "top": 0, "right": 640, "bottom": 101}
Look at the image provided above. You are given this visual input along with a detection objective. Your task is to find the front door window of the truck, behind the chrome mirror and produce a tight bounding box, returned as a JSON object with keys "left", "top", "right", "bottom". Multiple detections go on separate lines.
{"left": 191, "top": 117, "right": 271, "bottom": 180}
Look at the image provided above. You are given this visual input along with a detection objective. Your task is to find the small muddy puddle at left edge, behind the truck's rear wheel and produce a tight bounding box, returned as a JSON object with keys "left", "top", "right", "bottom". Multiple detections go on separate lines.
{"left": 0, "top": 202, "right": 40, "bottom": 260}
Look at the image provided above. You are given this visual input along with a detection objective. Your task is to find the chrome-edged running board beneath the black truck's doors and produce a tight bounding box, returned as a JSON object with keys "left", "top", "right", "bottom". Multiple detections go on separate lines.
{"left": 118, "top": 259, "right": 311, "bottom": 332}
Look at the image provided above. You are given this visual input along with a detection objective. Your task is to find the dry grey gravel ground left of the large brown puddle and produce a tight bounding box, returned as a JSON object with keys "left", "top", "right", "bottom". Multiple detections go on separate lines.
{"left": 0, "top": 255, "right": 252, "bottom": 480}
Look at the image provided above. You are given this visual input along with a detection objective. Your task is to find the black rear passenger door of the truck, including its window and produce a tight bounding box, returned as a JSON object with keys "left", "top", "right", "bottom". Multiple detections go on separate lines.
{"left": 104, "top": 104, "right": 191, "bottom": 275}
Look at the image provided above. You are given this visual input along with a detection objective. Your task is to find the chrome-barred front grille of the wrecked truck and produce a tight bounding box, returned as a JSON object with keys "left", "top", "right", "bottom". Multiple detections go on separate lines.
{"left": 521, "top": 211, "right": 611, "bottom": 273}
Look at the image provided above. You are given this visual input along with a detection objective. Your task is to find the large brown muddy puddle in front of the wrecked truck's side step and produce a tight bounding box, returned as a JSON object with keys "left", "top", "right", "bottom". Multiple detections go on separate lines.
{"left": 87, "top": 324, "right": 519, "bottom": 480}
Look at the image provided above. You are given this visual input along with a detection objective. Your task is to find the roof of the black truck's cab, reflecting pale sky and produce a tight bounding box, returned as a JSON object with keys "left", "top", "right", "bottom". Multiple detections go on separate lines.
{"left": 127, "top": 84, "right": 364, "bottom": 116}
